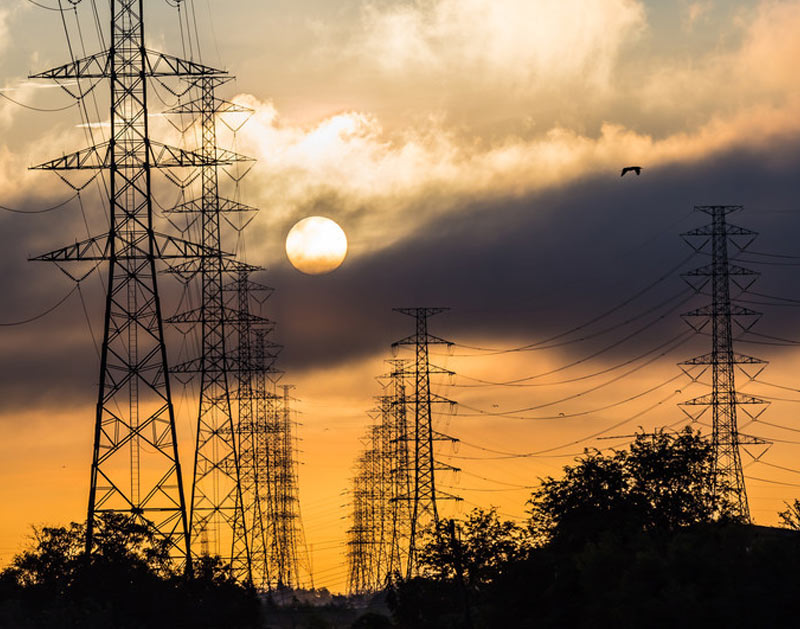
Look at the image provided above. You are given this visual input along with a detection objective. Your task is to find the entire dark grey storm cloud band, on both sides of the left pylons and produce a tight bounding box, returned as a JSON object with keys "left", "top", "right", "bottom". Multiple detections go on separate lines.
{"left": 0, "top": 132, "right": 800, "bottom": 409}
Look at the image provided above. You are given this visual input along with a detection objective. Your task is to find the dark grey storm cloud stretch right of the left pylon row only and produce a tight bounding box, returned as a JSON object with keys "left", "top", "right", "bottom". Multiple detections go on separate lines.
{"left": 269, "top": 132, "right": 800, "bottom": 368}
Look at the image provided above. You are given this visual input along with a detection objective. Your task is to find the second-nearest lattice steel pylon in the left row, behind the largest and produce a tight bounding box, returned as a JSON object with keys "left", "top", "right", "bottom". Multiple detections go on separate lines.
{"left": 166, "top": 76, "right": 257, "bottom": 582}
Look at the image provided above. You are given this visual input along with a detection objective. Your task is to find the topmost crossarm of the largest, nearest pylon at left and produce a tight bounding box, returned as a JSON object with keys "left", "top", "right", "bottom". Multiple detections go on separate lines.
{"left": 28, "top": 50, "right": 227, "bottom": 81}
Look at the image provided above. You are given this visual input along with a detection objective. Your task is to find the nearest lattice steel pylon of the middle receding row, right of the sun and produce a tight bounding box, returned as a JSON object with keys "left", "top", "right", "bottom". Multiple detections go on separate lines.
{"left": 392, "top": 308, "right": 461, "bottom": 577}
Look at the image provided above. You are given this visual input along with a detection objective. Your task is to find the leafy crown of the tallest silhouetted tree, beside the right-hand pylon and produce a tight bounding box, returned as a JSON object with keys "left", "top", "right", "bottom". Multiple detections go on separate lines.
{"left": 528, "top": 428, "right": 733, "bottom": 546}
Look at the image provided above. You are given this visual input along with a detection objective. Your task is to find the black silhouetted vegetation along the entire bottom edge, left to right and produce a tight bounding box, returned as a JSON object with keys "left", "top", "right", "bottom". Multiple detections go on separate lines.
{"left": 0, "top": 424, "right": 800, "bottom": 629}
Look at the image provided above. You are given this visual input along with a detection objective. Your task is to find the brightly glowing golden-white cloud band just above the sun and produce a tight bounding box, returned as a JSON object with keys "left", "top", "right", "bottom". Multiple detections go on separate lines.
{"left": 227, "top": 86, "right": 800, "bottom": 265}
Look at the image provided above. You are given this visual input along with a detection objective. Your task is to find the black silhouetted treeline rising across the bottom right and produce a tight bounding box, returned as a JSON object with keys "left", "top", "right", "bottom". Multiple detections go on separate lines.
{"left": 374, "top": 429, "right": 800, "bottom": 629}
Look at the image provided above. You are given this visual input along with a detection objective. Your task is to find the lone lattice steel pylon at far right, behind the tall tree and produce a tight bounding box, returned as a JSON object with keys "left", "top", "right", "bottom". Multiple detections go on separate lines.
{"left": 680, "top": 205, "right": 767, "bottom": 522}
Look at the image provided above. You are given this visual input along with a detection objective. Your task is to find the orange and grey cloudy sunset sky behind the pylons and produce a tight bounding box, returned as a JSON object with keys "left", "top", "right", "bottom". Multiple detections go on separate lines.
{"left": 0, "top": 0, "right": 800, "bottom": 590}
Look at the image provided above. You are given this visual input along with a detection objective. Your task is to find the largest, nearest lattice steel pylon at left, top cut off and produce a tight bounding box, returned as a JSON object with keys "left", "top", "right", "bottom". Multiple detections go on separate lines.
{"left": 31, "top": 0, "right": 242, "bottom": 564}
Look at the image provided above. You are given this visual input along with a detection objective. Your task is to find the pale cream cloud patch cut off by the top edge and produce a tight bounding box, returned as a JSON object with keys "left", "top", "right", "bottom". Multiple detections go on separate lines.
{"left": 358, "top": 0, "right": 645, "bottom": 84}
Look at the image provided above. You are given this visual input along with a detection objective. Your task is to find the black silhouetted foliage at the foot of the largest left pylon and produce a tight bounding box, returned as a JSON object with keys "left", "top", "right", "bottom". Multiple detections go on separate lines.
{"left": 0, "top": 515, "right": 259, "bottom": 629}
